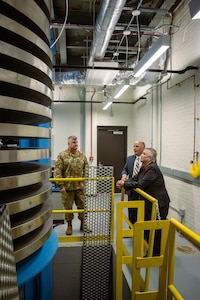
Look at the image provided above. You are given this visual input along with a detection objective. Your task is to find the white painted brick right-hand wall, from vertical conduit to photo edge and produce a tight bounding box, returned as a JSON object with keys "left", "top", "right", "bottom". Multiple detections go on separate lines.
{"left": 161, "top": 1, "right": 200, "bottom": 234}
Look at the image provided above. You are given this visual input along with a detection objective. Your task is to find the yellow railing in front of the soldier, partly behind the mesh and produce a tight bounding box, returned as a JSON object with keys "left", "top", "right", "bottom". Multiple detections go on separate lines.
{"left": 49, "top": 177, "right": 114, "bottom": 243}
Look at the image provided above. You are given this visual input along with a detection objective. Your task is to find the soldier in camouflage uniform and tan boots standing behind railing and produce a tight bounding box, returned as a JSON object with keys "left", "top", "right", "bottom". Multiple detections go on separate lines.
{"left": 54, "top": 136, "right": 88, "bottom": 235}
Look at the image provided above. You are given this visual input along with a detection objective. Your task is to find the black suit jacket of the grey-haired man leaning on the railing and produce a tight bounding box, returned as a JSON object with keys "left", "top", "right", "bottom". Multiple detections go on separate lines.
{"left": 124, "top": 162, "right": 170, "bottom": 207}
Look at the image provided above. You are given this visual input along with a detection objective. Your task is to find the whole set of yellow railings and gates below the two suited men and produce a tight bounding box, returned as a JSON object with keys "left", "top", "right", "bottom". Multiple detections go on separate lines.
{"left": 116, "top": 189, "right": 200, "bottom": 300}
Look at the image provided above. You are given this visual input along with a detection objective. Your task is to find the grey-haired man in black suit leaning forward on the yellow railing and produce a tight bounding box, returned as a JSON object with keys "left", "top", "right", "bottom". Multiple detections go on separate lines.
{"left": 116, "top": 148, "right": 170, "bottom": 256}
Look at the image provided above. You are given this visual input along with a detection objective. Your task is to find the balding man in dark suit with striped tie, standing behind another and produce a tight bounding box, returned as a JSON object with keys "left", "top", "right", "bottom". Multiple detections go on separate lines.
{"left": 121, "top": 141, "right": 145, "bottom": 224}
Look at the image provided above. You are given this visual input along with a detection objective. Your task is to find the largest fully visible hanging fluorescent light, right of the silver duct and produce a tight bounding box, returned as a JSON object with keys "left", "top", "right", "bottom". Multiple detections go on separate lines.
{"left": 133, "top": 35, "right": 170, "bottom": 77}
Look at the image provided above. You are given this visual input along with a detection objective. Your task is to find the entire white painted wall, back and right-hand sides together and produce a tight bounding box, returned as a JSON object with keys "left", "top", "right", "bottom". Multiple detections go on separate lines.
{"left": 52, "top": 1, "right": 200, "bottom": 234}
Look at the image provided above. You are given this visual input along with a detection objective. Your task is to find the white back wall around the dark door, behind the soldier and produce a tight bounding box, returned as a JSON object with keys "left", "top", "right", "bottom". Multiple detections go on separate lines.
{"left": 52, "top": 87, "right": 134, "bottom": 165}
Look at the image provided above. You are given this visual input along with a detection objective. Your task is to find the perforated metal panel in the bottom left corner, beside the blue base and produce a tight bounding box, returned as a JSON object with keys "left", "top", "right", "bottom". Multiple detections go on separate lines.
{"left": 0, "top": 205, "right": 19, "bottom": 300}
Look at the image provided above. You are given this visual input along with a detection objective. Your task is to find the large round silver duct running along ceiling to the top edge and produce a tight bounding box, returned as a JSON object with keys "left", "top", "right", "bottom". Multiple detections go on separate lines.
{"left": 88, "top": 0, "right": 126, "bottom": 66}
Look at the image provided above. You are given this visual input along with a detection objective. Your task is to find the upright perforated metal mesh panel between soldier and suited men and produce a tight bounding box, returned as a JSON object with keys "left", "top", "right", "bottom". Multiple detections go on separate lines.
{"left": 82, "top": 166, "right": 113, "bottom": 300}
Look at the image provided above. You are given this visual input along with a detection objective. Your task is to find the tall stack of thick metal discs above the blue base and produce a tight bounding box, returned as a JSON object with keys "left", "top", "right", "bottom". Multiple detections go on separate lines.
{"left": 0, "top": 0, "right": 52, "bottom": 262}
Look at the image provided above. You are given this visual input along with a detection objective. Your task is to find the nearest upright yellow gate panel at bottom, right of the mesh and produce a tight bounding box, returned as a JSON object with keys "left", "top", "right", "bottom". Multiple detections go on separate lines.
{"left": 131, "top": 220, "right": 169, "bottom": 300}
